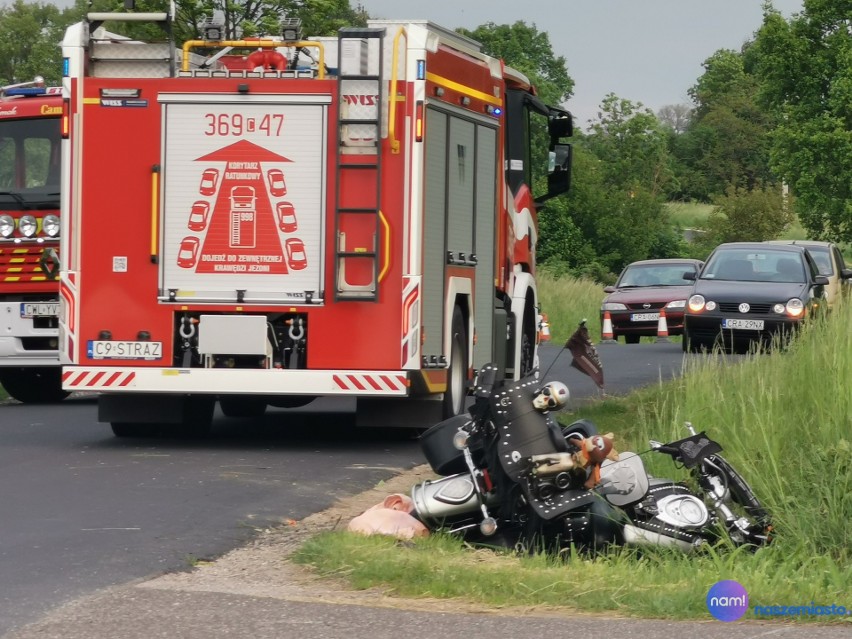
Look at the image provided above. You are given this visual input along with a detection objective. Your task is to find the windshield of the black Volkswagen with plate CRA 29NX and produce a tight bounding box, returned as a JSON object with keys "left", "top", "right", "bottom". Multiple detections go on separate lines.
{"left": 701, "top": 249, "right": 805, "bottom": 283}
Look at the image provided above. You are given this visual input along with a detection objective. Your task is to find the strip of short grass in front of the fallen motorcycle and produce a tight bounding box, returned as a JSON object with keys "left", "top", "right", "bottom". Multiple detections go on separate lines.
{"left": 294, "top": 531, "right": 852, "bottom": 621}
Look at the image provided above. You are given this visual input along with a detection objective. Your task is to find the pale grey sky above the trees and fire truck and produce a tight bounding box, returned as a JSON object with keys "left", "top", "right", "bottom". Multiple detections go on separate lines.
{"left": 350, "top": 0, "right": 803, "bottom": 129}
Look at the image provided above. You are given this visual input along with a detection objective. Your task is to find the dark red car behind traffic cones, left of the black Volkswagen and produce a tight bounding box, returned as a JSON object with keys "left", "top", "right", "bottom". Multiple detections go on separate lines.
{"left": 601, "top": 258, "right": 704, "bottom": 344}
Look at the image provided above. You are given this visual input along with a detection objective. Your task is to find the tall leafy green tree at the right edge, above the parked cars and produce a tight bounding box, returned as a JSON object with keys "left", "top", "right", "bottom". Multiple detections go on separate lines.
{"left": 748, "top": 0, "right": 852, "bottom": 241}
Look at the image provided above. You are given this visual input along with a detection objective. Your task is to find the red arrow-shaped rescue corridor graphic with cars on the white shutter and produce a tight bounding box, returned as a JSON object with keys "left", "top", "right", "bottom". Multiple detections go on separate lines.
{"left": 177, "top": 140, "right": 294, "bottom": 274}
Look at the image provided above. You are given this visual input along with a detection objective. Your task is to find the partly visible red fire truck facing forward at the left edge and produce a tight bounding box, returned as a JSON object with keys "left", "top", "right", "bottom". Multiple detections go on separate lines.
{"left": 0, "top": 78, "right": 68, "bottom": 402}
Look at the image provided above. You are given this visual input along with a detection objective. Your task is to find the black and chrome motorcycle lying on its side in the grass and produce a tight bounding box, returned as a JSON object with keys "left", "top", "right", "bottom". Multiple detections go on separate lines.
{"left": 411, "top": 364, "right": 771, "bottom": 551}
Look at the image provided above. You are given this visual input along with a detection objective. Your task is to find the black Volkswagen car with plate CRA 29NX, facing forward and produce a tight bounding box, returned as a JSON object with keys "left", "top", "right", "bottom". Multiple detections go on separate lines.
{"left": 683, "top": 242, "right": 828, "bottom": 351}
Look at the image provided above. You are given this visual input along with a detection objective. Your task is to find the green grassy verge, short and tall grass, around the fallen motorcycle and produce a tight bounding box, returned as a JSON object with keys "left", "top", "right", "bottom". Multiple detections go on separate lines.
{"left": 296, "top": 283, "right": 852, "bottom": 623}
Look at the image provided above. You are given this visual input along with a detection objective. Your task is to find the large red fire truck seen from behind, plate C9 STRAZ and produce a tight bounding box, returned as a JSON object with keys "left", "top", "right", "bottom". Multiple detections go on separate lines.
{"left": 60, "top": 8, "right": 571, "bottom": 436}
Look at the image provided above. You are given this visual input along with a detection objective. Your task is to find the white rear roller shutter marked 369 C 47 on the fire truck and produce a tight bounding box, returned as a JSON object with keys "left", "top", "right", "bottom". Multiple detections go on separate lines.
{"left": 159, "top": 94, "right": 331, "bottom": 304}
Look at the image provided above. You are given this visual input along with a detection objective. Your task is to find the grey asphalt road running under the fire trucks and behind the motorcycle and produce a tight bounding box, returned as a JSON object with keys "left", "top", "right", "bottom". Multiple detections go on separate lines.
{"left": 0, "top": 343, "right": 693, "bottom": 636}
